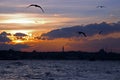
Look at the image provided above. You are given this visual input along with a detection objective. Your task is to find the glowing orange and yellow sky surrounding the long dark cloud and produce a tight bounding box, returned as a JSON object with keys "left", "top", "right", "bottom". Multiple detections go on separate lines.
{"left": 0, "top": 13, "right": 120, "bottom": 51}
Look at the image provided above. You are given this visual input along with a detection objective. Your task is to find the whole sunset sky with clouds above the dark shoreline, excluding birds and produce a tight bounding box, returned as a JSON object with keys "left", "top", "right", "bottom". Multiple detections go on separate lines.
{"left": 0, "top": 0, "right": 120, "bottom": 52}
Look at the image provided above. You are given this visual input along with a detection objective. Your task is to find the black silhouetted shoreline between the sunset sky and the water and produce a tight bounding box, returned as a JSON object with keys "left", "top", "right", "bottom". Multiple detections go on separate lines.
{"left": 0, "top": 49, "right": 120, "bottom": 61}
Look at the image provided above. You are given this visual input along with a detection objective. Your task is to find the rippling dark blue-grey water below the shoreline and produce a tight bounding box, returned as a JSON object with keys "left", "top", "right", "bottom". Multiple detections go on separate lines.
{"left": 0, "top": 60, "right": 120, "bottom": 80}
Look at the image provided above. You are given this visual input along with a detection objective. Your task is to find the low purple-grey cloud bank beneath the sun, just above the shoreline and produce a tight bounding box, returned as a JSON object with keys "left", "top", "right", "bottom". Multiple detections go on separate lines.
{"left": 0, "top": 43, "right": 30, "bottom": 50}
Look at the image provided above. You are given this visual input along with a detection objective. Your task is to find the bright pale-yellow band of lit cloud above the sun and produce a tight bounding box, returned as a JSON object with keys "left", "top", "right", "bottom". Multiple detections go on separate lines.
{"left": 0, "top": 14, "right": 48, "bottom": 25}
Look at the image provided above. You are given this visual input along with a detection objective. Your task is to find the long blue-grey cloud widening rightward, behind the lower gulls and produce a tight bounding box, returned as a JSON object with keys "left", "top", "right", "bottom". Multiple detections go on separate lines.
{"left": 40, "top": 22, "right": 120, "bottom": 39}
